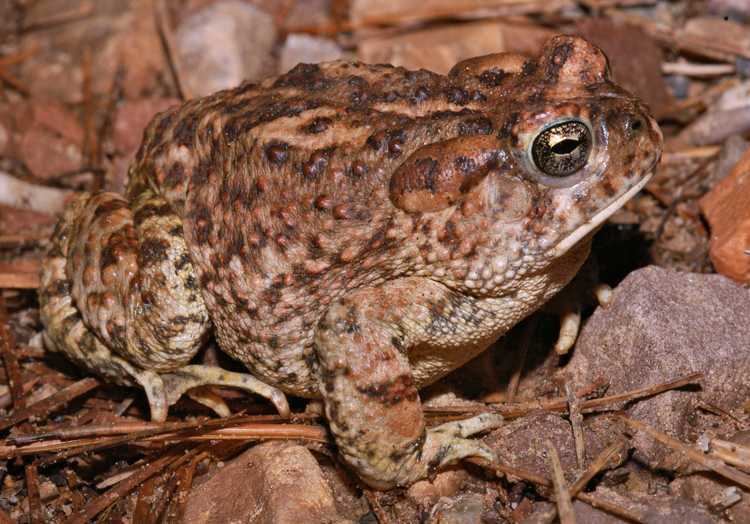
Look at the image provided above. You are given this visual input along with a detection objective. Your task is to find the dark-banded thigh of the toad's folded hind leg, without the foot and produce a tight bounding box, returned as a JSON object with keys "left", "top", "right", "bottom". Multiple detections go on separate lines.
{"left": 42, "top": 193, "right": 210, "bottom": 371}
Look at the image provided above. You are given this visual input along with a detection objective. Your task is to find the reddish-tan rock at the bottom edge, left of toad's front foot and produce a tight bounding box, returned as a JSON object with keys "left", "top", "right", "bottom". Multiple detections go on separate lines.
{"left": 183, "top": 442, "right": 350, "bottom": 524}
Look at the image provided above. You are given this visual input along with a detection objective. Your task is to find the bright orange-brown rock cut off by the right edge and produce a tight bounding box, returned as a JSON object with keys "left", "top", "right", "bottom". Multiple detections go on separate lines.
{"left": 700, "top": 147, "right": 750, "bottom": 284}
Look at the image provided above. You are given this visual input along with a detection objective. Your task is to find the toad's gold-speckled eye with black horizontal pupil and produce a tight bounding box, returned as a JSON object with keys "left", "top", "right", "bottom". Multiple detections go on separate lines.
{"left": 531, "top": 120, "right": 591, "bottom": 177}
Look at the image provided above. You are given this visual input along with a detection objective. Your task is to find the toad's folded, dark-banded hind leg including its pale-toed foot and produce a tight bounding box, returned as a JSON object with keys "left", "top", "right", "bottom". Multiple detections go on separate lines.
{"left": 39, "top": 191, "right": 289, "bottom": 420}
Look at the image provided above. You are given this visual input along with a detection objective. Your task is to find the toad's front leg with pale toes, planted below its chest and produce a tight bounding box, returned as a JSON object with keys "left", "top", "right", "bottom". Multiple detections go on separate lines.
{"left": 315, "top": 279, "right": 502, "bottom": 489}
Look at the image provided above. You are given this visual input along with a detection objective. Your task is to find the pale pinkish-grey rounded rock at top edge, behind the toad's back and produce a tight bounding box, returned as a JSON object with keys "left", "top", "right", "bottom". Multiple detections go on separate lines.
{"left": 175, "top": 0, "right": 276, "bottom": 98}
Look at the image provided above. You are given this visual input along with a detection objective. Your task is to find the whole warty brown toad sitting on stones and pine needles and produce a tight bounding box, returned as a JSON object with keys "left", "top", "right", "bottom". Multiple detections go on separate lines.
{"left": 40, "top": 37, "right": 661, "bottom": 488}
